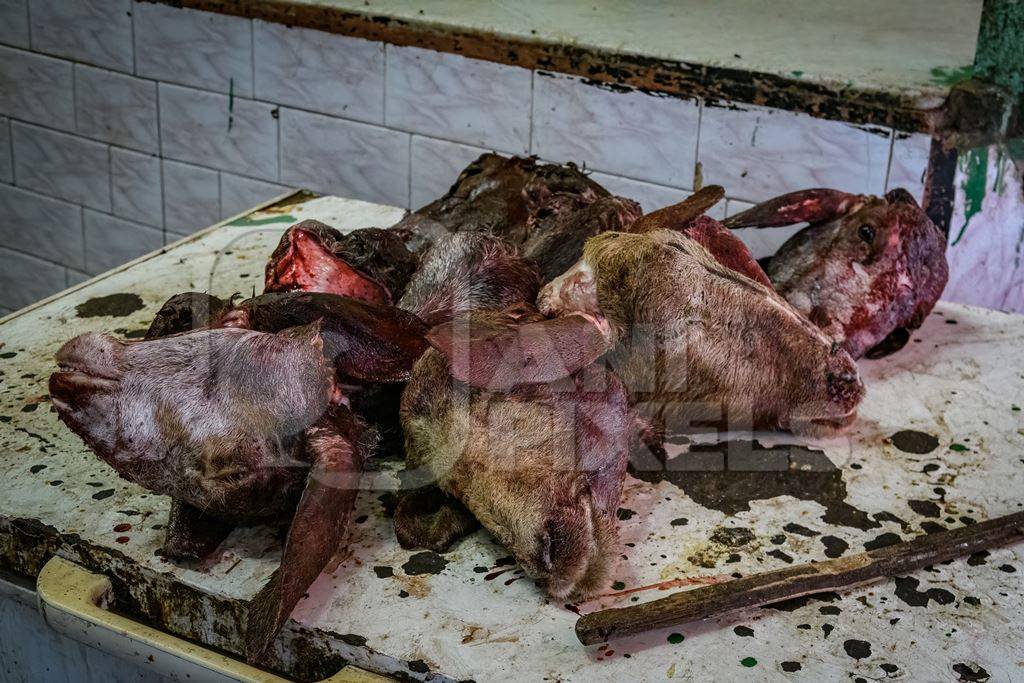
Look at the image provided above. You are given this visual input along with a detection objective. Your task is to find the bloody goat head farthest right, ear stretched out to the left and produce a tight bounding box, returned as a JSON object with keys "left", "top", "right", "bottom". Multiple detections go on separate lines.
{"left": 726, "top": 189, "right": 949, "bottom": 358}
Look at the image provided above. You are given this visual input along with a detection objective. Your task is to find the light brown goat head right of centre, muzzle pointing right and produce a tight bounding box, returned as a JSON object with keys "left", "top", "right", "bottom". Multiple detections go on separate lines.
{"left": 538, "top": 230, "right": 863, "bottom": 431}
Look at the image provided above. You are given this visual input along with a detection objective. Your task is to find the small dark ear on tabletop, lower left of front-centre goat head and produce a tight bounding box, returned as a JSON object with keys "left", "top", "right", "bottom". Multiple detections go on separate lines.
{"left": 394, "top": 484, "right": 480, "bottom": 553}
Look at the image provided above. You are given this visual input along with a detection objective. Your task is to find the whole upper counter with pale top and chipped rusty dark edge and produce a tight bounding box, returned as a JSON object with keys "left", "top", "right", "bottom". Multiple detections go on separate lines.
{"left": 160, "top": 0, "right": 982, "bottom": 130}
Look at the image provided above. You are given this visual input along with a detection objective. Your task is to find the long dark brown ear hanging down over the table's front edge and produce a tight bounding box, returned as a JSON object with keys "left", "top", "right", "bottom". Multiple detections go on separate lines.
{"left": 246, "top": 407, "right": 364, "bottom": 661}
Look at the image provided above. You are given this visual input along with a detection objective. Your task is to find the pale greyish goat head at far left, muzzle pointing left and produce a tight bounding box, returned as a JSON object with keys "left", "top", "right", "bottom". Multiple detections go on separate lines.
{"left": 49, "top": 325, "right": 335, "bottom": 509}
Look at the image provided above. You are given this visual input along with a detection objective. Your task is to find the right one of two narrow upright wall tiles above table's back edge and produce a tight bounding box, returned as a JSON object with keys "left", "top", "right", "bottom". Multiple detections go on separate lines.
{"left": 163, "top": 160, "right": 220, "bottom": 234}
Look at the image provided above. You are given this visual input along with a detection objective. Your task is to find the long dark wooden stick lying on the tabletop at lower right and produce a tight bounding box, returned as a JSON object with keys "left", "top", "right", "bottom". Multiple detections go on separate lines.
{"left": 575, "top": 512, "right": 1024, "bottom": 645}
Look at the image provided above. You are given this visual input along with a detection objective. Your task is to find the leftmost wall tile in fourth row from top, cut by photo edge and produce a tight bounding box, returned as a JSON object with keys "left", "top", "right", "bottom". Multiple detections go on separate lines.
{"left": 0, "top": 185, "right": 85, "bottom": 270}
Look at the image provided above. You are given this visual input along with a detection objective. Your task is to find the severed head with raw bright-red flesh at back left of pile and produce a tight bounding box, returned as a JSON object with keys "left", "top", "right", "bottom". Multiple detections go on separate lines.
{"left": 264, "top": 220, "right": 416, "bottom": 303}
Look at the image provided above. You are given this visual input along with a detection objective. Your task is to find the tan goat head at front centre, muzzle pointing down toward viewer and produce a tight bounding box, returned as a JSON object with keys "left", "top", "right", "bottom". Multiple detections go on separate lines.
{"left": 395, "top": 306, "right": 632, "bottom": 599}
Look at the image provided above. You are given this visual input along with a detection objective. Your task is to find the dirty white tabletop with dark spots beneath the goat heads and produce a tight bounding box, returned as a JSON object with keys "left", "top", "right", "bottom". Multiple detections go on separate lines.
{"left": 0, "top": 193, "right": 1024, "bottom": 681}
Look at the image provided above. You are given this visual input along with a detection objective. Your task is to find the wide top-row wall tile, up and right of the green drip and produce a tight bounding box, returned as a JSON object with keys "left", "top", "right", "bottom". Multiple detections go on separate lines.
{"left": 253, "top": 20, "right": 384, "bottom": 123}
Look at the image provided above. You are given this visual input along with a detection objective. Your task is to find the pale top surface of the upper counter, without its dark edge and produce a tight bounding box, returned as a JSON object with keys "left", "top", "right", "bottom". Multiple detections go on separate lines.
{"left": 317, "top": 0, "right": 982, "bottom": 108}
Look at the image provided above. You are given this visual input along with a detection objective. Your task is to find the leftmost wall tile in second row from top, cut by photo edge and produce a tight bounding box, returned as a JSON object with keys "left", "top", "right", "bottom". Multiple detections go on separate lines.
{"left": 0, "top": 47, "right": 75, "bottom": 130}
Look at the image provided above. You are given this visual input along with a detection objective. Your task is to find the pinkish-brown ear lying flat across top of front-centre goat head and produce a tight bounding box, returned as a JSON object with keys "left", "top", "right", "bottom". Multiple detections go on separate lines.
{"left": 427, "top": 312, "right": 611, "bottom": 391}
